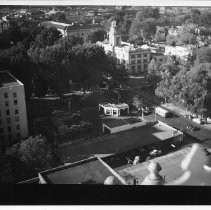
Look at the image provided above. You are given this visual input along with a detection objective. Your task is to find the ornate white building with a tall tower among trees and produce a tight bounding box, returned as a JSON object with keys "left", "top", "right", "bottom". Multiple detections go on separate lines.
{"left": 97, "top": 21, "right": 150, "bottom": 74}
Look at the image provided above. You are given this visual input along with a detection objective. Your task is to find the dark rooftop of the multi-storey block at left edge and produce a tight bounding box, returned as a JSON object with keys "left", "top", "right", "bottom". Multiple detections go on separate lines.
{"left": 0, "top": 70, "right": 22, "bottom": 87}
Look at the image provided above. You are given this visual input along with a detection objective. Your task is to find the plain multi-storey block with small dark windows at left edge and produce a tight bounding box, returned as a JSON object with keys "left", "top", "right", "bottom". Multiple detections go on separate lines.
{"left": 0, "top": 71, "right": 28, "bottom": 151}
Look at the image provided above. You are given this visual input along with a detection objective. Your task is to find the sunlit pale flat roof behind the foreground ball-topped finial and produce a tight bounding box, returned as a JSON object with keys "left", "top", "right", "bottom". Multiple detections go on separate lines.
{"left": 116, "top": 147, "right": 191, "bottom": 184}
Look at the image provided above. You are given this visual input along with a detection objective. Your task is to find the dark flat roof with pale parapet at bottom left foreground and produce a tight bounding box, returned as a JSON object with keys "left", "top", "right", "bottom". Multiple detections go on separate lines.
{"left": 40, "top": 157, "right": 113, "bottom": 184}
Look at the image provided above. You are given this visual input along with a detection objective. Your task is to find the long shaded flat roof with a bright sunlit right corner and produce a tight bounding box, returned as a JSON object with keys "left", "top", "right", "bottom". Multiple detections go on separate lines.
{"left": 57, "top": 123, "right": 180, "bottom": 162}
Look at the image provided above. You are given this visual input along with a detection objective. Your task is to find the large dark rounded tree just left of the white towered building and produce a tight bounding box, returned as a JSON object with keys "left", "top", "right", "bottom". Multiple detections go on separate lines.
{"left": 65, "top": 44, "right": 107, "bottom": 93}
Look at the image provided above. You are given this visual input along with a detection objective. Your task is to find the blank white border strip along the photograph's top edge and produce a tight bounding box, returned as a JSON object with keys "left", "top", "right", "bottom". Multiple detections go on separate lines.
{"left": 0, "top": 0, "right": 211, "bottom": 7}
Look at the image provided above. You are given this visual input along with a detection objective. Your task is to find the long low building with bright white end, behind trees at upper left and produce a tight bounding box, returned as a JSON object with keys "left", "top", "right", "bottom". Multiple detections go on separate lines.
{"left": 40, "top": 21, "right": 103, "bottom": 41}
